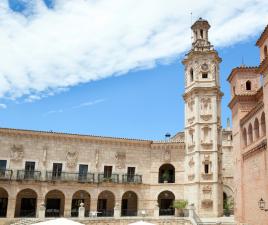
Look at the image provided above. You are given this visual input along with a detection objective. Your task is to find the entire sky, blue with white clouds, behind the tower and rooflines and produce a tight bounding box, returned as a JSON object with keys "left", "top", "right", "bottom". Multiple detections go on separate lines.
{"left": 0, "top": 0, "right": 268, "bottom": 140}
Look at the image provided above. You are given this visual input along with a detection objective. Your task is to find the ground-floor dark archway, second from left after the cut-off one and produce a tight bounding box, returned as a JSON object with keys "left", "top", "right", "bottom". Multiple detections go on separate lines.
{"left": 15, "top": 188, "right": 37, "bottom": 217}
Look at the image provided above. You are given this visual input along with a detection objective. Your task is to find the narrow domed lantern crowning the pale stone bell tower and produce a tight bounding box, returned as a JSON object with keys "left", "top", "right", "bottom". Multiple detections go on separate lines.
{"left": 191, "top": 18, "right": 213, "bottom": 51}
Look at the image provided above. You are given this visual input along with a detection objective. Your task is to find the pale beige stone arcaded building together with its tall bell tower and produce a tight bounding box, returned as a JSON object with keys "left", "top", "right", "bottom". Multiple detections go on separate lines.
{"left": 0, "top": 18, "right": 233, "bottom": 222}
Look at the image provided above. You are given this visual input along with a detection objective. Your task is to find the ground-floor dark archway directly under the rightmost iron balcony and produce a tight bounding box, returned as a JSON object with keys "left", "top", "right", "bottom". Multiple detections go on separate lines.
{"left": 121, "top": 191, "right": 138, "bottom": 216}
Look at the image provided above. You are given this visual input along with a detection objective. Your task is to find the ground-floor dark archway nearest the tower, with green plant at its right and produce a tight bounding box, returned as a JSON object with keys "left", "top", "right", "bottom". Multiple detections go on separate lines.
{"left": 158, "top": 191, "right": 175, "bottom": 216}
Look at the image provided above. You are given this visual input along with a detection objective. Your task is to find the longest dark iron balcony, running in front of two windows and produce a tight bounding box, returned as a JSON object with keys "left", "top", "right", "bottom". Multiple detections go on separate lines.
{"left": 46, "top": 171, "right": 95, "bottom": 183}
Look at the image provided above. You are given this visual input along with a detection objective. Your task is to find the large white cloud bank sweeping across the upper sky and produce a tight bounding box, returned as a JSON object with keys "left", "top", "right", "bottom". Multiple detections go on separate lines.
{"left": 0, "top": 0, "right": 268, "bottom": 101}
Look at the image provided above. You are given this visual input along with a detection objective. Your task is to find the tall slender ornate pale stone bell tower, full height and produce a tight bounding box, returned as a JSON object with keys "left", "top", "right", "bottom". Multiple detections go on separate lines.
{"left": 183, "top": 18, "right": 223, "bottom": 217}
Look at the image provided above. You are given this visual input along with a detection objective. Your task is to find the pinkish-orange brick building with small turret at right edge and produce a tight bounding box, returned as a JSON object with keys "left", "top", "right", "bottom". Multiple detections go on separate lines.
{"left": 228, "top": 24, "right": 268, "bottom": 225}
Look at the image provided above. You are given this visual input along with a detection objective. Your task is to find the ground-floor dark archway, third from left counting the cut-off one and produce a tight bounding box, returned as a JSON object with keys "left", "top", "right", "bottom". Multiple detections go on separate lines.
{"left": 45, "top": 190, "right": 65, "bottom": 217}
